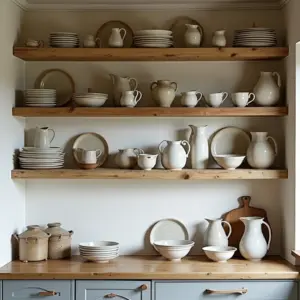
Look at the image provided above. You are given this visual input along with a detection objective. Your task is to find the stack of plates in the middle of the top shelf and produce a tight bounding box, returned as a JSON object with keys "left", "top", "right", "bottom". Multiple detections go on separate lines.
{"left": 133, "top": 29, "right": 174, "bottom": 48}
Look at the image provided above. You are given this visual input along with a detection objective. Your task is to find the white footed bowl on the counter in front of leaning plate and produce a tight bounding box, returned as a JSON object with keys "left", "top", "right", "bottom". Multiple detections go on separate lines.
{"left": 153, "top": 240, "right": 195, "bottom": 261}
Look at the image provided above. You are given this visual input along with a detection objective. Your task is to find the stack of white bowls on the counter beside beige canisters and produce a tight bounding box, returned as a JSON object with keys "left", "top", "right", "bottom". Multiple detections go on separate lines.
{"left": 79, "top": 242, "right": 119, "bottom": 263}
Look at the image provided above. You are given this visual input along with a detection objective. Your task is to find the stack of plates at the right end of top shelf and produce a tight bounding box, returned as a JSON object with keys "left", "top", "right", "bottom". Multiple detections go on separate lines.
{"left": 233, "top": 27, "right": 277, "bottom": 47}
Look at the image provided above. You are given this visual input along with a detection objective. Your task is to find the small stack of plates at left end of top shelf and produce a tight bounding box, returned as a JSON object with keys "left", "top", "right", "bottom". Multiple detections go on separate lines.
{"left": 49, "top": 32, "right": 79, "bottom": 48}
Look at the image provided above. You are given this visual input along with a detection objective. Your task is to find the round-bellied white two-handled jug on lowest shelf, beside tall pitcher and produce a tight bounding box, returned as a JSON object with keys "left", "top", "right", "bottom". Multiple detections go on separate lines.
{"left": 158, "top": 141, "right": 191, "bottom": 170}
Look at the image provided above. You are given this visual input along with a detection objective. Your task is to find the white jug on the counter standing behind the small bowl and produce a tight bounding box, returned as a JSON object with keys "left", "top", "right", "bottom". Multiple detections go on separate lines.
{"left": 203, "top": 219, "right": 232, "bottom": 247}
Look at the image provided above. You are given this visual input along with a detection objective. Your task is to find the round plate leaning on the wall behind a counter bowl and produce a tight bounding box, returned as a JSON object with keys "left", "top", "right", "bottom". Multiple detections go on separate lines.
{"left": 150, "top": 219, "right": 189, "bottom": 251}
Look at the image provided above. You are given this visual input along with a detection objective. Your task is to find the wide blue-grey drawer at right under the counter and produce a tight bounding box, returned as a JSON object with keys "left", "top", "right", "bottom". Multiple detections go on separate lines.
{"left": 154, "top": 280, "right": 298, "bottom": 300}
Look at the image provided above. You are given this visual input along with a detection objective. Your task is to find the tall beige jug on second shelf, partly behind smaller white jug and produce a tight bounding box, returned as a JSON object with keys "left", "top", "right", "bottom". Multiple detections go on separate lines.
{"left": 110, "top": 74, "right": 138, "bottom": 106}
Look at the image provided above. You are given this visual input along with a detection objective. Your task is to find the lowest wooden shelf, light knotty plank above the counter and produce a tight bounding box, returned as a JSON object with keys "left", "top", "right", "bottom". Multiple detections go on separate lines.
{"left": 11, "top": 168, "right": 288, "bottom": 180}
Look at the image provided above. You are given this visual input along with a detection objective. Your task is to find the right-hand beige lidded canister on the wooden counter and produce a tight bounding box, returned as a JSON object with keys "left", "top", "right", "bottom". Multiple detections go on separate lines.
{"left": 45, "top": 223, "right": 73, "bottom": 259}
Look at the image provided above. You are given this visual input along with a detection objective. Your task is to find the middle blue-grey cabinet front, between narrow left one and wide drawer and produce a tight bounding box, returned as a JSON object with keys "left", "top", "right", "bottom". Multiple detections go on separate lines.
{"left": 76, "top": 280, "right": 150, "bottom": 300}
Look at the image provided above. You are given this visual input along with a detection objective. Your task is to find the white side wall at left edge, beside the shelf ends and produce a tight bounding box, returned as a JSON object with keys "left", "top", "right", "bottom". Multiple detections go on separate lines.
{"left": 0, "top": 0, "right": 25, "bottom": 265}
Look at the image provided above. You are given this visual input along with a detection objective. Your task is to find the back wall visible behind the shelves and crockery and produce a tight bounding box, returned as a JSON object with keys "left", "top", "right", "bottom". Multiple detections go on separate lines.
{"left": 23, "top": 11, "right": 285, "bottom": 254}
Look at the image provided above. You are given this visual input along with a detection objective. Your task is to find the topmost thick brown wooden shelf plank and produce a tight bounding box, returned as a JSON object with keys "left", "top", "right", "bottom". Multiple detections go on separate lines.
{"left": 13, "top": 47, "right": 289, "bottom": 61}
